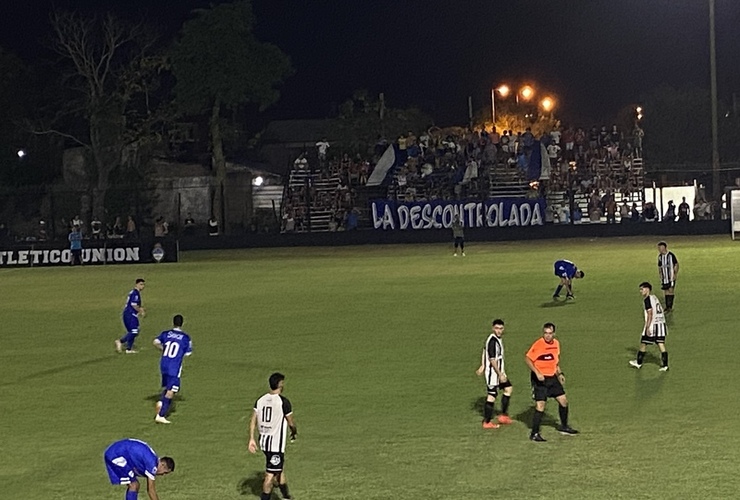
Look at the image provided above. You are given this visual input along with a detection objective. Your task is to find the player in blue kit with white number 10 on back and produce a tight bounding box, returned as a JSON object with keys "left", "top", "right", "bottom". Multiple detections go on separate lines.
{"left": 154, "top": 314, "right": 193, "bottom": 424}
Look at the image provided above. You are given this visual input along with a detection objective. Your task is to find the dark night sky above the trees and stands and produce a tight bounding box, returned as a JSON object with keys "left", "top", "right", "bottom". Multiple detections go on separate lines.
{"left": 0, "top": 0, "right": 740, "bottom": 125}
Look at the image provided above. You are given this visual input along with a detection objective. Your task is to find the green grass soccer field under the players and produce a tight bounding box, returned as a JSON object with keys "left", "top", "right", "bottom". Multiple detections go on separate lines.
{"left": 0, "top": 236, "right": 740, "bottom": 500}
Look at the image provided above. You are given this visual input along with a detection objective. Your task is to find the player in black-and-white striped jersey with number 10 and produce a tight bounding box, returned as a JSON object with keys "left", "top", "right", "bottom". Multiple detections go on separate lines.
{"left": 249, "top": 373, "right": 298, "bottom": 500}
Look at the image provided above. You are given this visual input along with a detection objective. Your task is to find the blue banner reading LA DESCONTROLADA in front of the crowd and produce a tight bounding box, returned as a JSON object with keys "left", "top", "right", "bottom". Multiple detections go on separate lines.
{"left": 370, "top": 198, "right": 545, "bottom": 230}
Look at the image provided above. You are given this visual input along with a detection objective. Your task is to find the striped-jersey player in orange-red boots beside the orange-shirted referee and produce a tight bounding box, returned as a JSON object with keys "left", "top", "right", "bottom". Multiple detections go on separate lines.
{"left": 476, "top": 319, "right": 513, "bottom": 429}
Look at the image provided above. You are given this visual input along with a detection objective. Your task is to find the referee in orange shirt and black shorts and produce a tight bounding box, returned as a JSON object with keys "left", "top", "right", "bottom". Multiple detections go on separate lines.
{"left": 525, "top": 323, "right": 578, "bottom": 442}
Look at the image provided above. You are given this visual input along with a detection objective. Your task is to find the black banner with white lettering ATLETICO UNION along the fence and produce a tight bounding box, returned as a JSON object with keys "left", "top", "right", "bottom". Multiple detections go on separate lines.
{"left": 0, "top": 240, "right": 178, "bottom": 268}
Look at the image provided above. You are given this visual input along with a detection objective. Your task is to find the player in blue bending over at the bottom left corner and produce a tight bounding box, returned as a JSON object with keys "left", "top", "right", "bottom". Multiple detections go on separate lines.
{"left": 103, "top": 439, "right": 175, "bottom": 500}
